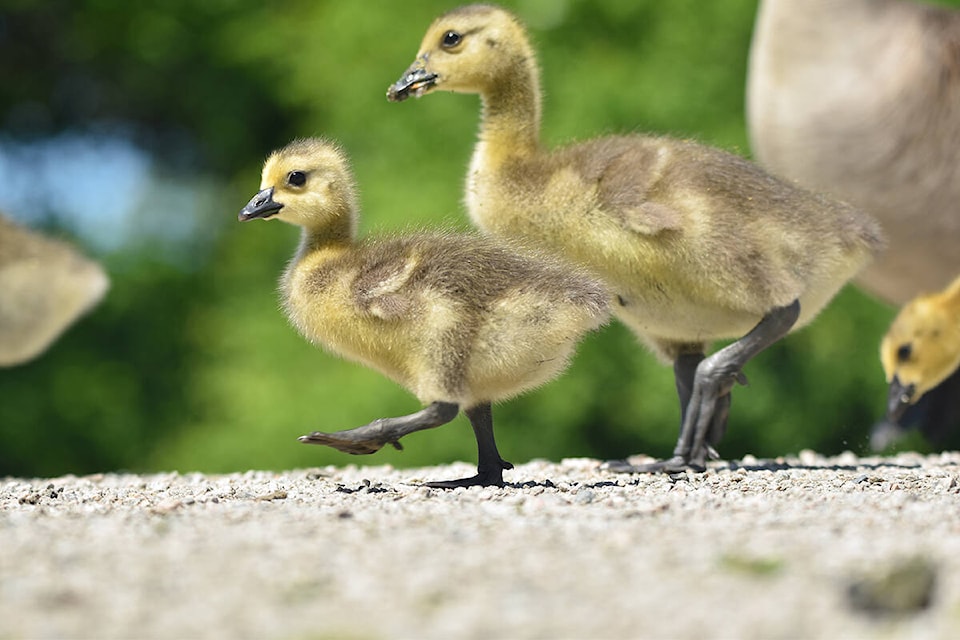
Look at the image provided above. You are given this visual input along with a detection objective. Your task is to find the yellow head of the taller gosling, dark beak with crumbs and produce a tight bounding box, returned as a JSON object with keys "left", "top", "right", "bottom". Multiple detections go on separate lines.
{"left": 387, "top": 4, "right": 534, "bottom": 102}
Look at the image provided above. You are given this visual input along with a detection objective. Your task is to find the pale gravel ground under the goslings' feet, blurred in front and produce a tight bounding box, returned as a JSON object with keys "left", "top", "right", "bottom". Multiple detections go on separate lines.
{"left": 0, "top": 452, "right": 960, "bottom": 640}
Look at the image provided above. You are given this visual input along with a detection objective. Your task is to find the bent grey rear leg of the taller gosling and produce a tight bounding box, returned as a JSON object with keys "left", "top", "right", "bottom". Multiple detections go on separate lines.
{"left": 673, "top": 300, "right": 800, "bottom": 470}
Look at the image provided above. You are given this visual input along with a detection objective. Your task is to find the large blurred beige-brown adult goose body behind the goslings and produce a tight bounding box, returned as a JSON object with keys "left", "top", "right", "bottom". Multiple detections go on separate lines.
{"left": 747, "top": 0, "right": 960, "bottom": 305}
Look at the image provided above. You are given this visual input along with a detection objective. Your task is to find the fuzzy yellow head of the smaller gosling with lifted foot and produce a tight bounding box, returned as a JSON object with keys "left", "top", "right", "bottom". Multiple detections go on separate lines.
{"left": 238, "top": 138, "right": 357, "bottom": 237}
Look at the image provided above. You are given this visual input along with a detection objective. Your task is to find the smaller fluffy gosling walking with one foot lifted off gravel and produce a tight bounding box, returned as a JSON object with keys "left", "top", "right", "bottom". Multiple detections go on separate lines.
{"left": 239, "top": 139, "right": 608, "bottom": 488}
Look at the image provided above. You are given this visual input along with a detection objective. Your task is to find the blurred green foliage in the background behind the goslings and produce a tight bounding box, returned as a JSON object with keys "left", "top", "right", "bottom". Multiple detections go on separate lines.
{"left": 0, "top": 0, "right": 936, "bottom": 475}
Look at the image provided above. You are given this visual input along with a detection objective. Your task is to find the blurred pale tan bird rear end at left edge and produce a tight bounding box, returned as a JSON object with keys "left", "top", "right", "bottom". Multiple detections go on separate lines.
{"left": 0, "top": 215, "right": 110, "bottom": 367}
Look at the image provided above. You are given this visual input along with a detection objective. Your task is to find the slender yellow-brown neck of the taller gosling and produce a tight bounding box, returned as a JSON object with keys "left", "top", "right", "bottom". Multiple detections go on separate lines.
{"left": 480, "top": 58, "right": 540, "bottom": 156}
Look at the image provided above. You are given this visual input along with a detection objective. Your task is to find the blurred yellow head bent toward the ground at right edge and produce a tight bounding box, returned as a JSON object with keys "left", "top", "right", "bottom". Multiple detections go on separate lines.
{"left": 880, "top": 294, "right": 960, "bottom": 422}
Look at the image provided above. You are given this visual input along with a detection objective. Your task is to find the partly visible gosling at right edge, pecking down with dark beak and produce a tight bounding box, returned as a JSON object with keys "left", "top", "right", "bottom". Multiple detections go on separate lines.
{"left": 871, "top": 276, "right": 960, "bottom": 449}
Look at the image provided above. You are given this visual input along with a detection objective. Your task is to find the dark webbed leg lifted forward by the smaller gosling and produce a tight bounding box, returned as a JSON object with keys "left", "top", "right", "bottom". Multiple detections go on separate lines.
{"left": 299, "top": 402, "right": 464, "bottom": 455}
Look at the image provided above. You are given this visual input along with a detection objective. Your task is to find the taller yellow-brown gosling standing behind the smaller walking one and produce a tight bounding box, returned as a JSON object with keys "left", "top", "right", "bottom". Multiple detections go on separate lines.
{"left": 387, "top": 5, "right": 882, "bottom": 472}
